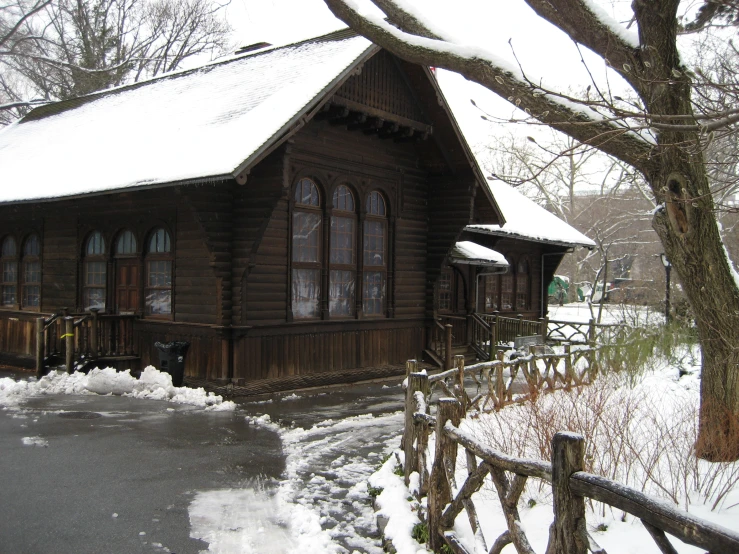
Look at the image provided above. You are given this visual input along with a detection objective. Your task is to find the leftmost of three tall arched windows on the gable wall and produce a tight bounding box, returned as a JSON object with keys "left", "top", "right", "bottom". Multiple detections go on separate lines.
{"left": 292, "top": 178, "right": 322, "bottom": 319}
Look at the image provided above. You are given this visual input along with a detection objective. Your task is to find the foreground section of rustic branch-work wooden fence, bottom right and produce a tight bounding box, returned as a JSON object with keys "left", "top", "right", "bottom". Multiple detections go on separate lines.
{"left": 402, "top": 362, "right": 739, "bottom": 554}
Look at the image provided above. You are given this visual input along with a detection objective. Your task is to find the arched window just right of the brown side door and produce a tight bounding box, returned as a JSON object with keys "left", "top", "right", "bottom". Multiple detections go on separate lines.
{"left": 145, "top": 228, "right": 172, "bottom": 315}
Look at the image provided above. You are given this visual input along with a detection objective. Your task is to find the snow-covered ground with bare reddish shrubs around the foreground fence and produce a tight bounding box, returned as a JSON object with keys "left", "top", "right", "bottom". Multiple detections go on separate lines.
{"left": 369, "top": 330, "right": 739, "bottom": 554}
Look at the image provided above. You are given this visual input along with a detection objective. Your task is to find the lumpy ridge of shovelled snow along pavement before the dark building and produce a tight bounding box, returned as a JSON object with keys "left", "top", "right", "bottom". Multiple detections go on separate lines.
{"left": 0, "top": 366, "right": 236, "bottom": 411}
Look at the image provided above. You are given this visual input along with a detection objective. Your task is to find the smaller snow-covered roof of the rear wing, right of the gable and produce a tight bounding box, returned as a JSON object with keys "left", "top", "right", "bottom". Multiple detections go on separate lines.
{"left": 466, "top": 181, "right": 595, "bottom": 247}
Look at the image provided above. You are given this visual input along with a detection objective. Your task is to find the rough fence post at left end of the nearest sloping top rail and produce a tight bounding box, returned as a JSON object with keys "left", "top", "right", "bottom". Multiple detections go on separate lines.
{"left": 428, "top": 398, "right": 462, "bottom": 552}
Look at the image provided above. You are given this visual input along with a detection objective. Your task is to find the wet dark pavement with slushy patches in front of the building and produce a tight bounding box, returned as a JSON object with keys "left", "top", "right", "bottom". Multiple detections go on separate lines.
{"left": 0, "top": 370, "right": 402, "bottom": 554}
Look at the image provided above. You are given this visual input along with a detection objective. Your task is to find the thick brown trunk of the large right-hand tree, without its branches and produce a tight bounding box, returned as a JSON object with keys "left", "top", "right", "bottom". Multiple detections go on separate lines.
{"left": 633, "top": 0, "right": 739, "bottom": 461}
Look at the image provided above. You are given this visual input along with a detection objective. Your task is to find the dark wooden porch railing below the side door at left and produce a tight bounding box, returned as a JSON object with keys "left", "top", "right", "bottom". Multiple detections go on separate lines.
{"left": 36, "top": 310, "right": 138, "bottom": 376}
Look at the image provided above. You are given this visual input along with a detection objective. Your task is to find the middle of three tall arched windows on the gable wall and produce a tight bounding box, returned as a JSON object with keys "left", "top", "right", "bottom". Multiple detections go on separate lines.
{"left": 328, "top": 185, "right": 357, "bottom": 316}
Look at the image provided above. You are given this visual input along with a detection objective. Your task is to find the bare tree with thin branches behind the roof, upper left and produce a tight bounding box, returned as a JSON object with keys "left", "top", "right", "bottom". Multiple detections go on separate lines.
{"left": 0, "top": 0, "right": 230, "bottom": 110}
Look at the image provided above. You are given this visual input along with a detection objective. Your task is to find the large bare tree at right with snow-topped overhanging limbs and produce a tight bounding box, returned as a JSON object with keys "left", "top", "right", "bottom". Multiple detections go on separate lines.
{"left": 325, "top": 0, "right": 739, "bottom": 460}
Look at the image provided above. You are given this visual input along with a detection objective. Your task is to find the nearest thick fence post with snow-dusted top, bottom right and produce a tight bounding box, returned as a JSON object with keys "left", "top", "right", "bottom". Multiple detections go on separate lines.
{"left": 547, "top": 432, "right": 588, "bottom": 554}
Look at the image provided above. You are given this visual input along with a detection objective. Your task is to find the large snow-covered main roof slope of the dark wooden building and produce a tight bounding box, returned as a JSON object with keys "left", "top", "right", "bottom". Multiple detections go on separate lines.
{"left": 0, "top": 31, "right": 378, "bottom": 203}
